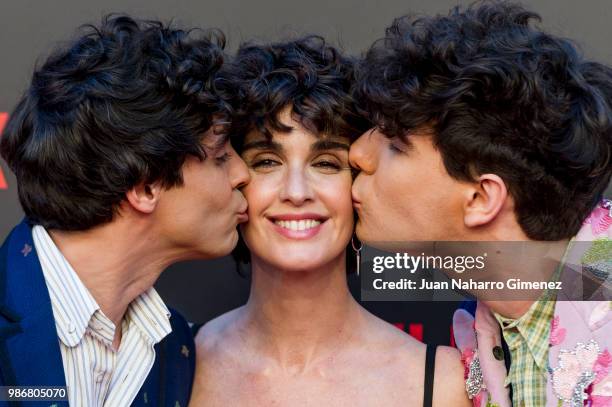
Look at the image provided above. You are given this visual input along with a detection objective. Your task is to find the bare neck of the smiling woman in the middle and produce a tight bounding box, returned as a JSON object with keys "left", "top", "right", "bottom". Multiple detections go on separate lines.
{"left": 243, "top": 256, "right": 362, "bottom": 372}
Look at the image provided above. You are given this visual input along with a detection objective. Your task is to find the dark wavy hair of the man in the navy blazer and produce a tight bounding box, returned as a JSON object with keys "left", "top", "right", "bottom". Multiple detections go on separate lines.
{"left": 0, "top": 15, "right": 225, "bottom": 230}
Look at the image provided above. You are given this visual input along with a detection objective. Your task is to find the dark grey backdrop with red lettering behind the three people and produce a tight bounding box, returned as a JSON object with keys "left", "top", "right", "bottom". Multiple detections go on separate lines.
{"left": 0, "top": 0, "right": 612, "bottom": 343}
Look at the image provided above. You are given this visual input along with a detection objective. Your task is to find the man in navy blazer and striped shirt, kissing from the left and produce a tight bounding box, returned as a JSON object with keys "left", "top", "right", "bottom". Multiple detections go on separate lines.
{"left": 0, "top": 15, "right": 249, "bottom": 406}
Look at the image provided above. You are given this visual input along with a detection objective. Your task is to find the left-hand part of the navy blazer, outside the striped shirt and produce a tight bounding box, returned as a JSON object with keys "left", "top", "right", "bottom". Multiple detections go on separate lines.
{"left": 0, "top": 220, "right": 67, "bottom": 405}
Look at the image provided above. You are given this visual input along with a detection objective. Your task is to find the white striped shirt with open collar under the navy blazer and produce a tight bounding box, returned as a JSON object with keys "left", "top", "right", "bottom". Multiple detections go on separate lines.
{"left": 32, "top": 225, "right": 172, "bottom": 407}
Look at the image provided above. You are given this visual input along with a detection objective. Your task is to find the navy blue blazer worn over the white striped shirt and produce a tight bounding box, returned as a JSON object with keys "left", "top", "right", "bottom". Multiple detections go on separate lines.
{"left": 0, "top": 220, "right": 195, "bottom": 407}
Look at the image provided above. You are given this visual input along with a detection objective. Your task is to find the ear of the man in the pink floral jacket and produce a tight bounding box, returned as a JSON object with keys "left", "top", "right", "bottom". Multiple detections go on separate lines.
{"left": 463, "top": 174, "right": 508, "bottom": 227}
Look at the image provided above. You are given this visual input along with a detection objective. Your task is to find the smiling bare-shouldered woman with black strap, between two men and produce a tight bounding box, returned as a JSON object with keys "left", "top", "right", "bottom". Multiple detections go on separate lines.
{"left": 191, "top": 37, "right": 468, "bottom": 406}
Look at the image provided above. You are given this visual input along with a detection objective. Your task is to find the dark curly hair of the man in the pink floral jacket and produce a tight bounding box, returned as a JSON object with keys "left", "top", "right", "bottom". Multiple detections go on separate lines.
{"left": 355, "top": 2, "right": 612, "bottom": 240}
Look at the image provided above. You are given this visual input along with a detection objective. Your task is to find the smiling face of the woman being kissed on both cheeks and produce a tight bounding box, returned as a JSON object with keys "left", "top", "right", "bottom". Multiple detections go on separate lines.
{"left": 242, "top": 107, "right": 354, "bottom": 271}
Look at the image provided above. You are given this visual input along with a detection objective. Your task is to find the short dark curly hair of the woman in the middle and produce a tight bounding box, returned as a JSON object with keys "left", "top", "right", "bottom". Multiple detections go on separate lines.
{"left": 215, "top": 36, "right": 367, "bottom": 148}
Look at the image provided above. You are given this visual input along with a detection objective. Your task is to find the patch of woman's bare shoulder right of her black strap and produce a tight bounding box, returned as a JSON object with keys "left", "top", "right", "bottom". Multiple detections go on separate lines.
{"left": 433, "top": 346, "right": 472, "bottom": 407}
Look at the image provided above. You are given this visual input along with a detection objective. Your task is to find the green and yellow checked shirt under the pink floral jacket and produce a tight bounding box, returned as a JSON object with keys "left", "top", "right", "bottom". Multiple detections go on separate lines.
{"left": 495, "top": 297, "right": 555, "bottom": 407}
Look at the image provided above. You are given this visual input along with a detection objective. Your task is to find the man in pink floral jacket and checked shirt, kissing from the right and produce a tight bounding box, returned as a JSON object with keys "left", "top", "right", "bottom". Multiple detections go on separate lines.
{"left": 350, "top": 2, "right": 612, "bottom": 406}
